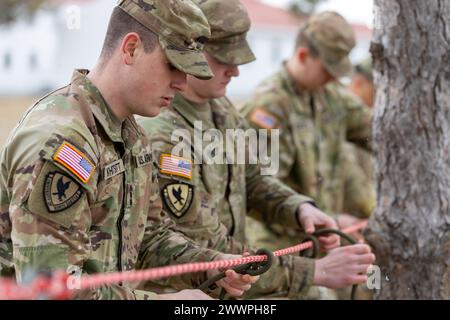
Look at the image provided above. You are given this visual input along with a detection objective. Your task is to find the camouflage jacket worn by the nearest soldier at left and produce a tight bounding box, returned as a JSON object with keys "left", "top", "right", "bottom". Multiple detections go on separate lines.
{"left": 0, "top": 71, "right": 217, "bottom": 299}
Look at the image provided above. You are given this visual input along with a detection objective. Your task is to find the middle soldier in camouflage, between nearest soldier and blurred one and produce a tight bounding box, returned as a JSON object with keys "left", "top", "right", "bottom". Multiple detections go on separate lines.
{"left": 138, "top": 0, "right": 373, "bottom": 298}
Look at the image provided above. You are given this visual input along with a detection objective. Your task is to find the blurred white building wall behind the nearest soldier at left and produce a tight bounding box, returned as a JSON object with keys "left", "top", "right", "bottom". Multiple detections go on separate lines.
{"left": 0, "top": 0, "right": 114, "bottom": 95}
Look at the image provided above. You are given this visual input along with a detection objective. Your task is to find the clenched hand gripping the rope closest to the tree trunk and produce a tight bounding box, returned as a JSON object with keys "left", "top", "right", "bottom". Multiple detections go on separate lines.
{"left": 313, "top": 244, "right": 375, "bottom": 289}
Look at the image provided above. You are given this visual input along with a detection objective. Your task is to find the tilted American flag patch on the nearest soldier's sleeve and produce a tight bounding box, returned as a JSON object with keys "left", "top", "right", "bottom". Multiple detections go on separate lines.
{"left": 53, "top": 141, "right": 96, "bottom": 183}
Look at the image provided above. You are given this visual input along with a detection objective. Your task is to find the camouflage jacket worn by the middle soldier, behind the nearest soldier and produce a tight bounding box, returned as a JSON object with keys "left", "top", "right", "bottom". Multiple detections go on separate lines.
{"left": 138, "top": 94, "right": 314, "bottom": 295}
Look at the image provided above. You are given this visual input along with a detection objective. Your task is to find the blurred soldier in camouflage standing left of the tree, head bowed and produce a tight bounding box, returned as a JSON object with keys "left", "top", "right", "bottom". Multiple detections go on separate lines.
{"left": 242, "top": 12, "right": 375, "bottom": 298}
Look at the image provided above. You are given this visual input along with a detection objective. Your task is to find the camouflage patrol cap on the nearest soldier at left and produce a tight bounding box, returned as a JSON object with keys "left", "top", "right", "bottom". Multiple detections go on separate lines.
{"left": 118, "top": 0, "right": 213, "bottom": 79}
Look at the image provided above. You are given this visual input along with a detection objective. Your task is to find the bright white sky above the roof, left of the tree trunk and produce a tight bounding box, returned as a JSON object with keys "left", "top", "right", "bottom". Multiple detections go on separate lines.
{"left": 263, "top": 0, "right": 373, "bottom": 27}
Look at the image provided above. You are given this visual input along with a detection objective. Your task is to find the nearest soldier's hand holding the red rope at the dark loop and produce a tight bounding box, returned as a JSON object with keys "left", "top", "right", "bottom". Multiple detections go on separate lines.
{"left": 208, "top": 253, "right": 259, "bottom": 297}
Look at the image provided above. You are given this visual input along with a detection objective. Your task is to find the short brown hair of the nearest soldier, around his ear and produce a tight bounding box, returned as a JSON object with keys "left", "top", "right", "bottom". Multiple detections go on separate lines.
{"left": 100, "top": 7, "right": 159, "bottom": 62}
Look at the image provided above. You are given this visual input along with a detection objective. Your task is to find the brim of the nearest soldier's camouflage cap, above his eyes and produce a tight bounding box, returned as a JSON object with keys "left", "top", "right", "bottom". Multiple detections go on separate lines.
{"left": 159, "top": 37, "right": 214, "bottom": 80}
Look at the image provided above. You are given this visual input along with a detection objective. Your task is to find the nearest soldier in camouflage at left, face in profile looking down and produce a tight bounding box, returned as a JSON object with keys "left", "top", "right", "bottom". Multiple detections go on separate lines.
{"left": 0, "top": 0, "right": 258, "bottom": 299}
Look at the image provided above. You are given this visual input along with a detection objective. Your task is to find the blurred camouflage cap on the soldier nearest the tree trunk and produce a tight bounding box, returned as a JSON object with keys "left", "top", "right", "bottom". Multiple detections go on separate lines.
{"left": 301, "top": 11, "right": 356, "bottom": 78}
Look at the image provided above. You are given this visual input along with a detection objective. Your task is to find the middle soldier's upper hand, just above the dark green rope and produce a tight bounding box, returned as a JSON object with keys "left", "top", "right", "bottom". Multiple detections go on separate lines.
{"left": 297, "top": 203, "right": 340, "bottom": 250}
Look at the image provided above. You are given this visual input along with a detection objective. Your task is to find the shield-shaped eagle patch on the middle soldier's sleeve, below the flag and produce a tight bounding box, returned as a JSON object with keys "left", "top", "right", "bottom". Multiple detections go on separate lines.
{"left": 162, "top": 183, "right": 194, "bottom": 218}
